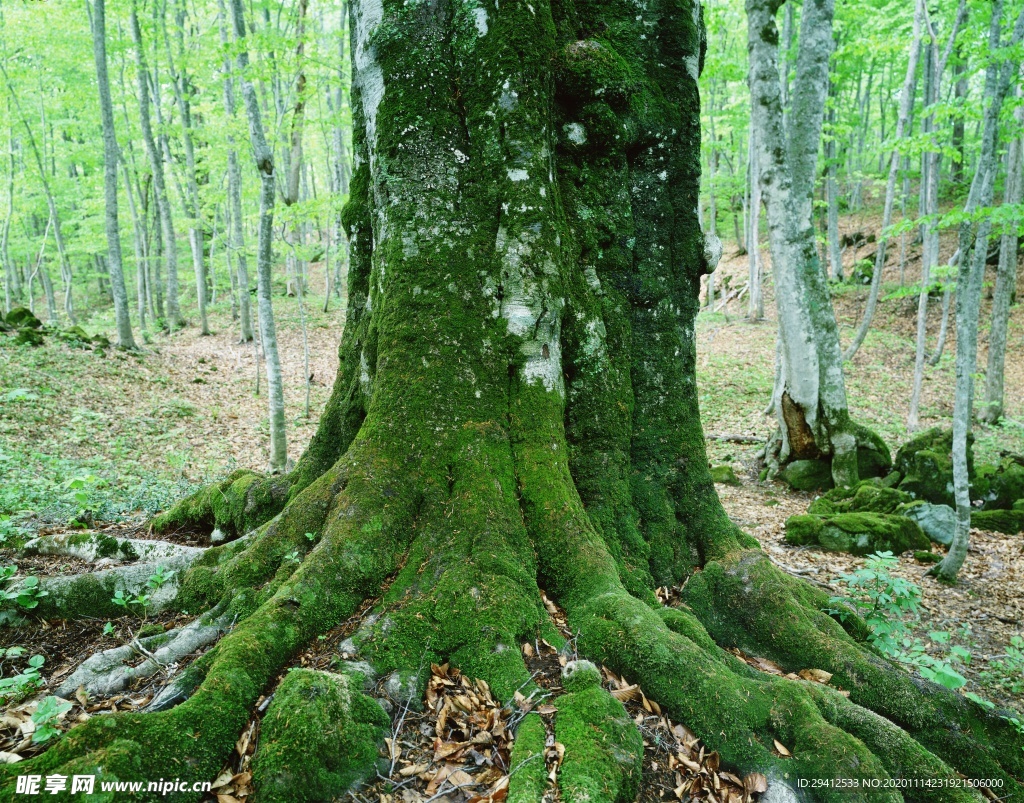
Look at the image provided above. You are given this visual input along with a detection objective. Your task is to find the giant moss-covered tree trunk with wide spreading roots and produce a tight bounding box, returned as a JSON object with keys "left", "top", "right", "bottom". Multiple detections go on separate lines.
{"left": 9, "top": 0, "right": 1024, "bottom": 801}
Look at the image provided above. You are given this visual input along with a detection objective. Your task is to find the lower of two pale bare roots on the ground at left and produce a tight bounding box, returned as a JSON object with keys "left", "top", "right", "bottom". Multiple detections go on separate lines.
{"left": 56, "top": 615, "right": 230, "bottom": 698}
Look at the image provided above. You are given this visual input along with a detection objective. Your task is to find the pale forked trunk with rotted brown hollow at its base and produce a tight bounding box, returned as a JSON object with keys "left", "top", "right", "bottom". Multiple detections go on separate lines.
{"left": 746, "top": 0, "right": 858, "bottom": 485}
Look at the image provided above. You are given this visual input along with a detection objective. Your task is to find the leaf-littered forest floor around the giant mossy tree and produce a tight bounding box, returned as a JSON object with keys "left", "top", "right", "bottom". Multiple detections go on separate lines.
{"left": 0, "top": 208, "right": 1024, "bottom": 801}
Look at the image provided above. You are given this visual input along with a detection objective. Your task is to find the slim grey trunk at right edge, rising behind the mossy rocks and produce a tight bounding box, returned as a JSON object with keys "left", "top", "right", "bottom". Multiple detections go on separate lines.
{"left": 978, "top": 73, "right": 1024, "bottom": 424}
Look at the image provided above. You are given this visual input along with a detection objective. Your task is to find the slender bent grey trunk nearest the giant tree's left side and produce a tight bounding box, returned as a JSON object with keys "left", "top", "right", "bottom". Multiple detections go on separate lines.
{"left": 229, "top": 0, "right": 289, "bottom": 473}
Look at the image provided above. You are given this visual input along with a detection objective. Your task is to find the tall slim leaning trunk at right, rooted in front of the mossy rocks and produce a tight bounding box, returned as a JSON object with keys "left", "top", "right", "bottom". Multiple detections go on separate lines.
{"left": 934, "top": 0, "right": 1024, "bottom": 583}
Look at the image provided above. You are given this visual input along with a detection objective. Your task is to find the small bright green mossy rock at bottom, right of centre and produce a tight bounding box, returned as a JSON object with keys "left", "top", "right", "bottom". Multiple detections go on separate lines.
{"left": 555, "top": 675, "right": 643, "bottom": 803}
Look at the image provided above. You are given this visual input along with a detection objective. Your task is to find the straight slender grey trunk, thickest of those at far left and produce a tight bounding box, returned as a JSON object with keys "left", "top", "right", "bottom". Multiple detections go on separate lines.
{"left": 92, "top": 0, "right": 137, "bottom": 349}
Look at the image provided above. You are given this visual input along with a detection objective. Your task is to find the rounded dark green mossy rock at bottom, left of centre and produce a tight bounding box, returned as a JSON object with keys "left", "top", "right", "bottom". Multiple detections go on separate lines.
{"left": 253, "top": 669, "right": 390, "bottom": 803}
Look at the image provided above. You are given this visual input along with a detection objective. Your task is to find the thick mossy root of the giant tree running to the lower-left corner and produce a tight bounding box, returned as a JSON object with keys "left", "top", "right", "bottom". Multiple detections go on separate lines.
{"left": 0, "top": 443, "right": 419, "bottom": 801}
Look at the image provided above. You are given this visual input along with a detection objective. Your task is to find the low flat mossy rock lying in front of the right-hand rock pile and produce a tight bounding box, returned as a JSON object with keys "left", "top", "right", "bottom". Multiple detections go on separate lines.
{"left": 785, "top": 513, "right": 929, "bottom": 555}
